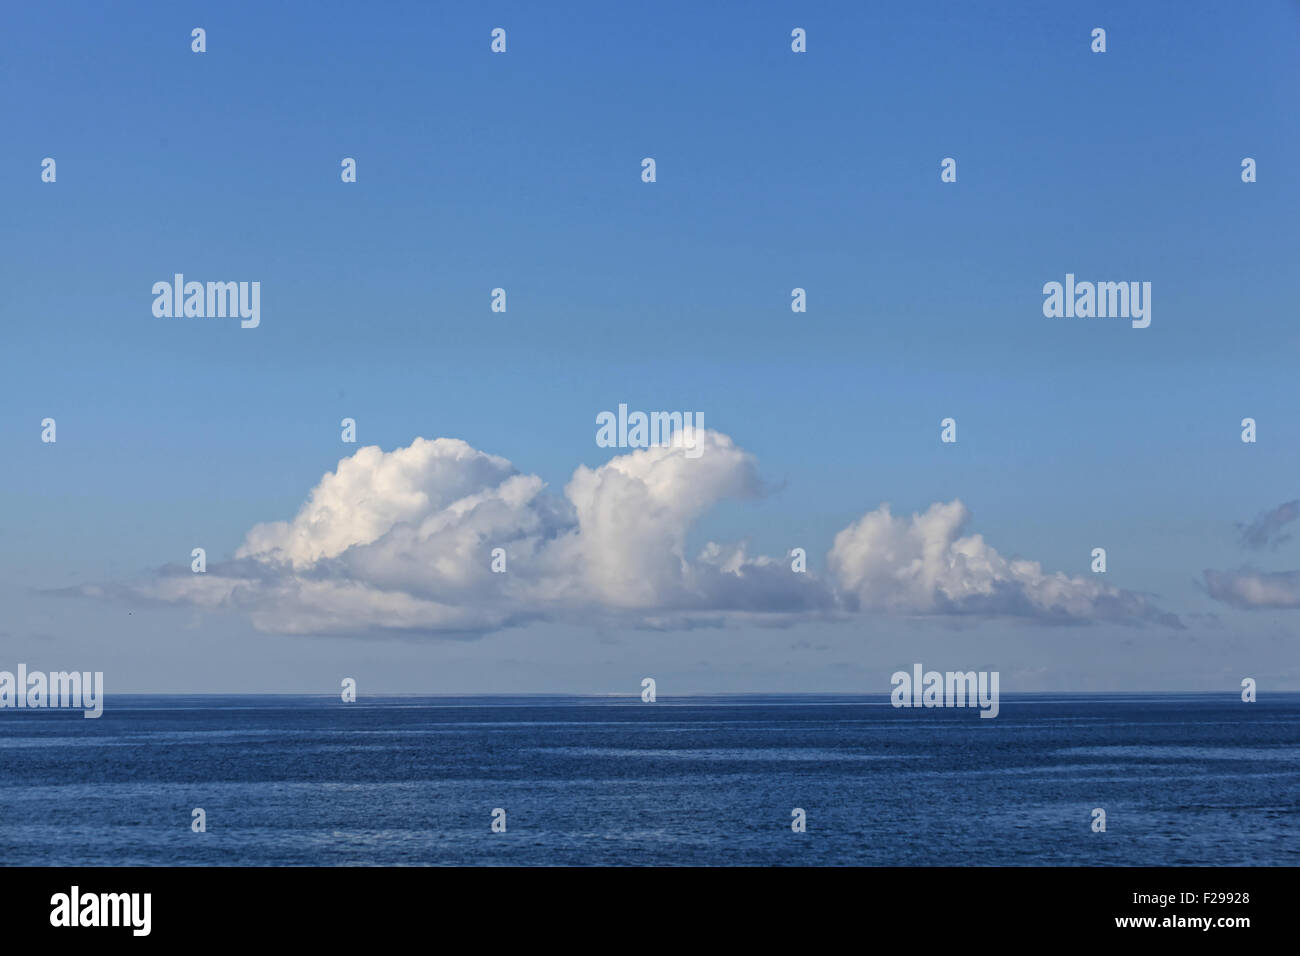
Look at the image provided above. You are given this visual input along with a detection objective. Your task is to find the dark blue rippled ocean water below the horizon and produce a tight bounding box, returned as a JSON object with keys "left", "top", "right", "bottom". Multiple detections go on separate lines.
{"left": 0, "top": 693, "right": 1300, "bottom": 866}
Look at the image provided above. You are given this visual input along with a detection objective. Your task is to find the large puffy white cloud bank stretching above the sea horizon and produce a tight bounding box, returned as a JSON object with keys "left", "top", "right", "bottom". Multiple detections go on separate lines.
{"left": 94, "top": 431, "right": 1179, "bottom": 636}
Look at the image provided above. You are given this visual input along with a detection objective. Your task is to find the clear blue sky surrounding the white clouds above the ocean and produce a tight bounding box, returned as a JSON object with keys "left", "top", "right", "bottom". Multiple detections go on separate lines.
{"left": 0, "top": 1, "right": 1300, "bottom": 695}
